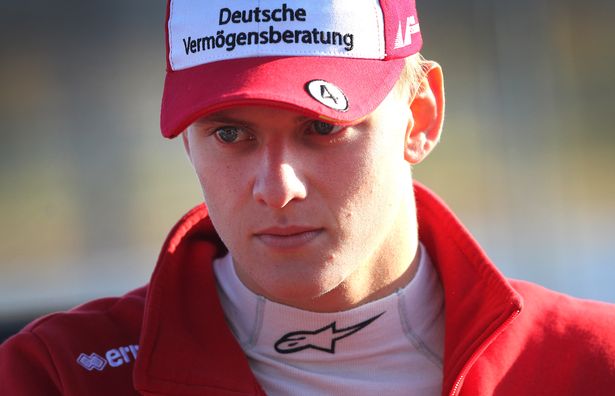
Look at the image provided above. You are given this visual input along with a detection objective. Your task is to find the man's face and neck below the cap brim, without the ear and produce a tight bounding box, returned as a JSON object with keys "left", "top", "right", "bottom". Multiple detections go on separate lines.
{"left": 184, "top": 88, "right": 416, "bottom": 311}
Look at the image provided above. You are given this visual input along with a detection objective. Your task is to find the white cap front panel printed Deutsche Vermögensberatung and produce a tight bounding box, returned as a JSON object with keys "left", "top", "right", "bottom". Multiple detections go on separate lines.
{"left": 168, "top": 0, "right": 385, "bottom": 70}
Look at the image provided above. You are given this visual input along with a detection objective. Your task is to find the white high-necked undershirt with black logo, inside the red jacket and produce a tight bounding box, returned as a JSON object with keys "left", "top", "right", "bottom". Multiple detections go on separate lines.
{"left": 214, "top": 245, "right": 444, "bottom": 396}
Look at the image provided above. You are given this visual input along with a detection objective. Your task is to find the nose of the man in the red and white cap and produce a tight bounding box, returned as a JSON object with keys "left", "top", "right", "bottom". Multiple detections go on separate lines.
{"left": 252, "top": 150, "right": 307, "bottom": 209}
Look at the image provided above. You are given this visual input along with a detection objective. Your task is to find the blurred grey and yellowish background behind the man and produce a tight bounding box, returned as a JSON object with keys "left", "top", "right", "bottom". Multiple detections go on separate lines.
{"left": 0, "top": 0, "right": 615, "bottom": 340}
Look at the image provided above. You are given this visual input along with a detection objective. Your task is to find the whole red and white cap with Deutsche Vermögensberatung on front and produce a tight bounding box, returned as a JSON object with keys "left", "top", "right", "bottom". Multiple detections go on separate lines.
{"left": 160, "top": 0, "right": 422, "bottom": 138}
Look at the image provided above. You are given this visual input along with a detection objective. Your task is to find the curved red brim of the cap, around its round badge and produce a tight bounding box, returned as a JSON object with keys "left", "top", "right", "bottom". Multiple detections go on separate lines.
{"left": 160, "top": 57, "right": 404, "bottom": 138}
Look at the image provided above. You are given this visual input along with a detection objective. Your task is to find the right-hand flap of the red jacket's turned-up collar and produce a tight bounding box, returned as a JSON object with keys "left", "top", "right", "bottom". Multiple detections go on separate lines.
{"left": 414, "top": 182, "right": 523, "bottom": 394}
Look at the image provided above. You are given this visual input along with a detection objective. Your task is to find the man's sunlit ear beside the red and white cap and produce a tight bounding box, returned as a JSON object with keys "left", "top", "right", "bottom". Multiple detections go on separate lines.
{"left": 405, "top": 62, "right": 444, "bottom": 165}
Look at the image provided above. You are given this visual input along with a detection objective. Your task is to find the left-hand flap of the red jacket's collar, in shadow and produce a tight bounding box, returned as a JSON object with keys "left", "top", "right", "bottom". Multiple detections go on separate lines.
{"left": 133, "top": 205, "right": 260, "bottom": 395}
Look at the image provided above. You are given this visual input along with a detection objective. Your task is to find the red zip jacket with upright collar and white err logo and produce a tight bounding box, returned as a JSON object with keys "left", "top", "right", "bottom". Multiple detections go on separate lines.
{"left": 0, "top": 185, "right": 615, "bottom": 396}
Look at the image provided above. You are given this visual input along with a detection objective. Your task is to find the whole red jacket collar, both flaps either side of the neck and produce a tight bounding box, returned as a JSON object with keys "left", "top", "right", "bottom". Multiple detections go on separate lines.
{"left": 134, "top": 182, "right": 522, "bottom": 395}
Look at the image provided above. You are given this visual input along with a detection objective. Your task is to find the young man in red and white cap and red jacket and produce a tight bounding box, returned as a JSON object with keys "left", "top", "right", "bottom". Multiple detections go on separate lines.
{"left": 0, "top": 0, "right": 615, "bottom": 395}
